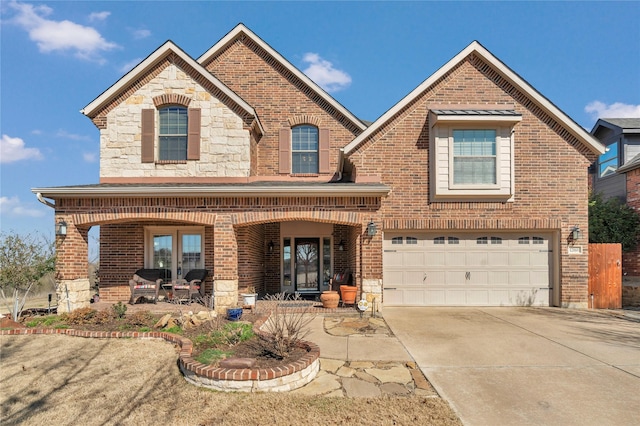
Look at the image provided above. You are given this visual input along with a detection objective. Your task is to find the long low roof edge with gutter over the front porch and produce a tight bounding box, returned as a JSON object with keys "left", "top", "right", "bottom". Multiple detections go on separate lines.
{"left": 31, "top": 181, "right": 389, "bottom": 199}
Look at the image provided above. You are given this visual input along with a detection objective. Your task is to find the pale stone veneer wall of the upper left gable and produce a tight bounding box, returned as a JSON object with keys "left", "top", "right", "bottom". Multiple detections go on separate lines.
{"left": 100, "top": 62, "right": 252, "bottom": 178}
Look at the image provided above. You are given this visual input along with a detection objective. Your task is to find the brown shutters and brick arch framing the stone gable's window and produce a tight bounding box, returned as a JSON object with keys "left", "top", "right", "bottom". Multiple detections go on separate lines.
{"left": 141, "top": 93, "right": 201, "bottom": 163}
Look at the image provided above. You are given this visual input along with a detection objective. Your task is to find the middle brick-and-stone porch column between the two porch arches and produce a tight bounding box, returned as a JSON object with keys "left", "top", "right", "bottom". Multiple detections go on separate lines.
{"left": 213, "top": 215, "right": 238, "bottom": 313}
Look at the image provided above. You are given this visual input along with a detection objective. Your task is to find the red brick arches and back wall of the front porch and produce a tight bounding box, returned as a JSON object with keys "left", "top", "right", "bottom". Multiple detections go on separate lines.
{"left": 56, "top": 197, "right": 380, "bottom": 301}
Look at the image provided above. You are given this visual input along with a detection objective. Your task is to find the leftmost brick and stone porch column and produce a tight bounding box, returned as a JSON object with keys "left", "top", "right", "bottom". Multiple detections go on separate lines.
{"left": 55, "top": 215, "right": 91, "bottom": 313}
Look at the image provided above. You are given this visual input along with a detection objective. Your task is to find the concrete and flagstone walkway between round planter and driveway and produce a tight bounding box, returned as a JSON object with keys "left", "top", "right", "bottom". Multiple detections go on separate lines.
{"left": 292, "top": 315, "right": 437, "bottom": 398}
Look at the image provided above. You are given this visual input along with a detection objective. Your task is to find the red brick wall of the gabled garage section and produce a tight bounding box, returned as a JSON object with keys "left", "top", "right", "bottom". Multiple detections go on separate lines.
{"left": 350, "top": 55, "right": 595, "bottom": 303}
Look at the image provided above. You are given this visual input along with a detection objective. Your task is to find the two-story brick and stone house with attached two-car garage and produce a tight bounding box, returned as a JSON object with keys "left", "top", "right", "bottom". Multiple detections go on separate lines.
{"left": 33, "top": 24, "right": 604, "bottom": 310}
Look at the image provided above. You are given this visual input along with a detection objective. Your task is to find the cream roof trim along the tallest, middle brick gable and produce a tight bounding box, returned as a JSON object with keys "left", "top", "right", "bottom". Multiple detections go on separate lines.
{"left": 198, "top": 23, "right": 367, "bottom": 130}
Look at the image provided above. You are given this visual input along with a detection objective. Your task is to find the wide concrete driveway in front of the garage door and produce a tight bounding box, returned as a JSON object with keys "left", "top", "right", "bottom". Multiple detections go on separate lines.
{"left": 384, "top": 307, "right": 640, "bottom": 425}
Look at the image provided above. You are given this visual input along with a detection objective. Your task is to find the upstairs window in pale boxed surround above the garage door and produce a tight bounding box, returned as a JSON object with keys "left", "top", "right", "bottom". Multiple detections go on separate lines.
{"left": 453, "top": 130, "right": 497, "bottom": 185}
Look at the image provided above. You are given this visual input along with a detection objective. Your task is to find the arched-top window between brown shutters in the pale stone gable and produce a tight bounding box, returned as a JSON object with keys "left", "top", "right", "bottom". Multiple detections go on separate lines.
{"left": 158, "top": 106, "right": 188, "bottom": 161}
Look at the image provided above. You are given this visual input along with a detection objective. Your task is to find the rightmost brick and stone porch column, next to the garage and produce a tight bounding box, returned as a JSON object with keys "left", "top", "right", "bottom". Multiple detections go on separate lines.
{"left": 361, "top": 218, "right": 382, "bottom": 311}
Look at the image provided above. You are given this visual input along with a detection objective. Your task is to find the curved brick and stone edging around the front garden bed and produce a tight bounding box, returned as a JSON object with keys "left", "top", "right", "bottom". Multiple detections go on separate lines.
{"left": 0, "top": 328, "right": 320, "bottom": 392}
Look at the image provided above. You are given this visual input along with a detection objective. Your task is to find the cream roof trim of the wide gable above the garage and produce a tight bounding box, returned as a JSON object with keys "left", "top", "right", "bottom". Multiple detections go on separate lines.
{"left": 344, "top": 41, "right": 604, "bottom": 155}
